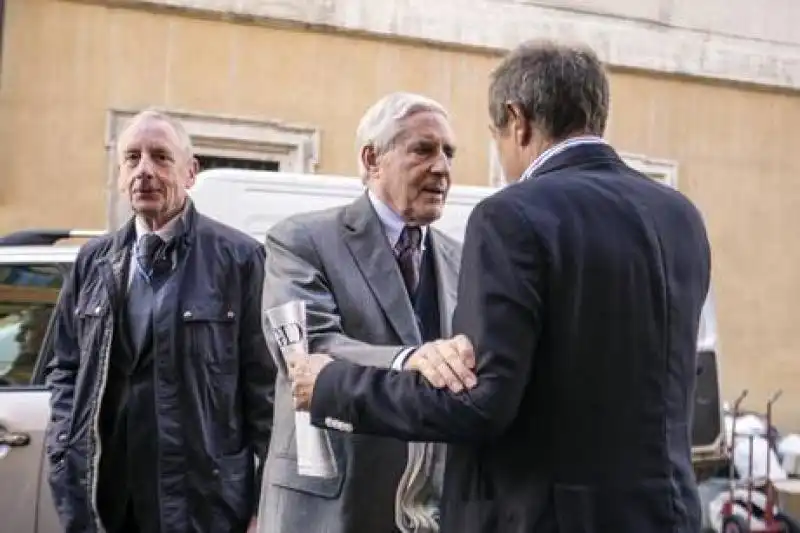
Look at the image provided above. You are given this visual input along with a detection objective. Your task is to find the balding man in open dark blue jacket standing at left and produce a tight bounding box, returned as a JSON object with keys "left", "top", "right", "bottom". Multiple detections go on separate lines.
{"left": 46, "top": 111, "right": 275, "bottom": 533}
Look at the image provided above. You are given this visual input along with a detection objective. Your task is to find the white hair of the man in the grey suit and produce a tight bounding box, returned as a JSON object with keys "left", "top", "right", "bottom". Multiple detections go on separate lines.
{"left": 356, "top": 92, "right": 448, "bottom": 182}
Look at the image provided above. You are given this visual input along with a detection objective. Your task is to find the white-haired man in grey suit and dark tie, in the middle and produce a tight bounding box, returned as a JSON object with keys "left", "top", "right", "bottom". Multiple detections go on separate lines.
{"left": 259, "top": 93, "right": 475, "bottom": 533}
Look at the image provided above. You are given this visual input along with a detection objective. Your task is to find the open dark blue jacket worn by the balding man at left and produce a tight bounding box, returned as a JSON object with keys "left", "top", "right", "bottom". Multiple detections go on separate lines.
{"left": 45, "top": 205, "right": 275, "bottom": 533}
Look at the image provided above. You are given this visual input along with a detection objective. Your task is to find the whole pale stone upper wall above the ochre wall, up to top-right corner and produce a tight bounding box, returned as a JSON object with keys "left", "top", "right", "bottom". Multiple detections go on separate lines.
{"left": 94, "top": 0, "right": 800, "bottom": 89}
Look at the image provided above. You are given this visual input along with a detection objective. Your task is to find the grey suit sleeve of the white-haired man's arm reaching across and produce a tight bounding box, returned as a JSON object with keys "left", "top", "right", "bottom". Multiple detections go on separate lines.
{"left": 263, "top": 219, "right": 406, "bottom": 368}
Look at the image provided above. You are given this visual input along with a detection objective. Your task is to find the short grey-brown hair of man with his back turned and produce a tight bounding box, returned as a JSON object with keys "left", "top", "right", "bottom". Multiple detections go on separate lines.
{"left": 489, "top": 41, "right": 609, "bottom": 140}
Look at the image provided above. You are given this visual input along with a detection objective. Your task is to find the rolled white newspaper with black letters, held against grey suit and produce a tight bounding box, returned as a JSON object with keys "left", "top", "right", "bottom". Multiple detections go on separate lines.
{"left": 266, "top": 300, "right": 337, "bottom": 478}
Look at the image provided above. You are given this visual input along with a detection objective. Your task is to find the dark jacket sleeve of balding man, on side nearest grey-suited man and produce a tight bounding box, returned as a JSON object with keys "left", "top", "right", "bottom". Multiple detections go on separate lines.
{"left": 239, "top": 245, "right": 277, "bottom": 512}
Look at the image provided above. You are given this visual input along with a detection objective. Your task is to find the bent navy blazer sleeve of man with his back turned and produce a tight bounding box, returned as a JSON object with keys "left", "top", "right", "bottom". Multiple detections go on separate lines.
{"left": 311, "top": 197, "right": 546, "bottom": 443}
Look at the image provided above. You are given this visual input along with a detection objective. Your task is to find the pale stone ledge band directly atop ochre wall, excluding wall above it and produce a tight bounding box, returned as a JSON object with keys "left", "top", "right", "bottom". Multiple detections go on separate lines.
{"left": 94, "top": 0, "right": 800, "bottom": 90}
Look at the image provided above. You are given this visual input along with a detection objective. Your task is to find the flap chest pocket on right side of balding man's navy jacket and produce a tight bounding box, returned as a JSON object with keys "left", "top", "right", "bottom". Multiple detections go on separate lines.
{"left": 181, "top": 300, "right": 239, "bottom": 374}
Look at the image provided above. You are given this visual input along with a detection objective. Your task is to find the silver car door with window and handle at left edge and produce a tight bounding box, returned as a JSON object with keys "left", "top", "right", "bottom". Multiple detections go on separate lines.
{"left": 0, "top": 253, "right": 68, "bottom": 533}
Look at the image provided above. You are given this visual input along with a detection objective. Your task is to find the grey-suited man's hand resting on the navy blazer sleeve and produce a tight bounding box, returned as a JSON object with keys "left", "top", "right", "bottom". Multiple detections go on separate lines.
{"left": 403, "top": 335, "right": 478, "bottom": 392}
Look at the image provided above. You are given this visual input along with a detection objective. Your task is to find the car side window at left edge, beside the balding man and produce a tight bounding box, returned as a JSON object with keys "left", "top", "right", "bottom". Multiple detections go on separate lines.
{"left": 0, "top": 264, "right": 63, "bottom": 388}
